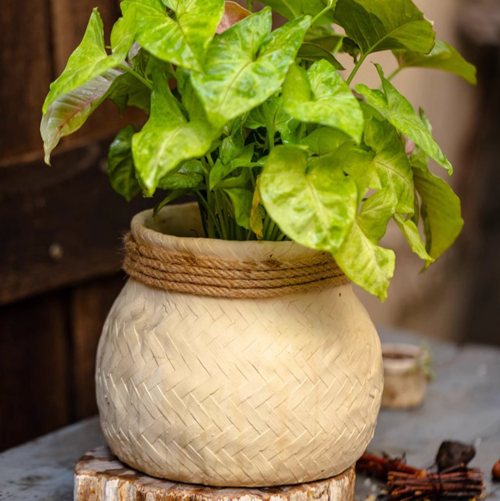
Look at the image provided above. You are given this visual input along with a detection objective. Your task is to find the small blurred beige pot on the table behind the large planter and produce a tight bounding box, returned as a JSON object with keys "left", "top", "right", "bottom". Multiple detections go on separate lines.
{"left": 382, "top": 344, "right": 428, "bottom": 409}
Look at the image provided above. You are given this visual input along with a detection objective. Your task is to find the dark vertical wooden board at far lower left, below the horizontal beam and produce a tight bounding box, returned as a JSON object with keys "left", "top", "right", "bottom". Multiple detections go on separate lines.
{"left": 0, "top": 292, "right": 71, "bottom": 450}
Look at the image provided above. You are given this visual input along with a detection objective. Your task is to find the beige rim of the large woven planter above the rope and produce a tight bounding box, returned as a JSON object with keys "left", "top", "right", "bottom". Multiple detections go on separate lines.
{"left": 131, "top": 202, "right": 330, "bottom": 262}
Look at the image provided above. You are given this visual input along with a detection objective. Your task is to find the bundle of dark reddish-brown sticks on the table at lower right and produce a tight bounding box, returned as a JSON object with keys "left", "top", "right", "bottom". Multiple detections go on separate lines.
{"left": 356, "top": 454, "right": 484, "bottom": 501}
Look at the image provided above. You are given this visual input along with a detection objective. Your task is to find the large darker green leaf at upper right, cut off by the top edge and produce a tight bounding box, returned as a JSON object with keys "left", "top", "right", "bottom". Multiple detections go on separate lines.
{"left": 335, "top": 0, "right": 436, "bottom": 58}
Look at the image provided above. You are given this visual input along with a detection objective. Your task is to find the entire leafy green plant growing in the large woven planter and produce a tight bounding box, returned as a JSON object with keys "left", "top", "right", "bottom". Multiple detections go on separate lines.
{"left": 41, "top": 0, "right": 476, "bottom": 300}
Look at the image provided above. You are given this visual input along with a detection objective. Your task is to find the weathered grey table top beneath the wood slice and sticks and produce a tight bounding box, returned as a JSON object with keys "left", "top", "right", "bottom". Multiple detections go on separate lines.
{"left": 0, "top": 331, "right": 500, "bottom": 501}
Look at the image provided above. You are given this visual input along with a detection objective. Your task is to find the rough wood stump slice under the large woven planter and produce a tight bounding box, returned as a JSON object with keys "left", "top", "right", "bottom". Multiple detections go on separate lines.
{"left": 74, "top": 447, "right": 355, "bottom": 501}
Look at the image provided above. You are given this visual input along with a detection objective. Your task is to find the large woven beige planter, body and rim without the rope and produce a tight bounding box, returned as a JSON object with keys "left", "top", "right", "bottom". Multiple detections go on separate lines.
{"left": 96, "top": 205, "right": 383, "bottom": 487}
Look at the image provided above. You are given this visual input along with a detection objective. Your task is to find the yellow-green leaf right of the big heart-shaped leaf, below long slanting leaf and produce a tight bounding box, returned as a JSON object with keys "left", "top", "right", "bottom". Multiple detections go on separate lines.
{"left": 364, "top": 118, "right": 415, "bottom": 214}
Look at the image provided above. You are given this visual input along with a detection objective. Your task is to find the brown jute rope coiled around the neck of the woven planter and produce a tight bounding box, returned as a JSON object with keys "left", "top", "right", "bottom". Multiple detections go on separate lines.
{"left": 123, "top": 233, "right": 349, "bottom": 299}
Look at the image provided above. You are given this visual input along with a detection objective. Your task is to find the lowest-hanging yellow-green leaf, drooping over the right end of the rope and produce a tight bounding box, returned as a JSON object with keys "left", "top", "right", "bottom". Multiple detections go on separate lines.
{"left": 334, "top": 213, "right": 396, "bottom": 301}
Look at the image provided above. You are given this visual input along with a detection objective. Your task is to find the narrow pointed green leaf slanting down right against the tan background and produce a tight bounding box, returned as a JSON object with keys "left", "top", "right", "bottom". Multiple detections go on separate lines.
{"left": 356, "top": 64, "right": 453, "bottom": 175}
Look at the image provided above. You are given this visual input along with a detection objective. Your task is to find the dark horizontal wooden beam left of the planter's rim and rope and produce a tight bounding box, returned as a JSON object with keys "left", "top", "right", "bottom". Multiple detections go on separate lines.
{"left": 0, "top": 141, "right": 165, "bottom": 304}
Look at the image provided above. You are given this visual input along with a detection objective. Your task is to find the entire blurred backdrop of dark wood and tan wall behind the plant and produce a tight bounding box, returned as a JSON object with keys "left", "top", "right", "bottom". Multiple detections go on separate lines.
{"left": 0, "top": 0, "right": 500, "bottom": 451}
